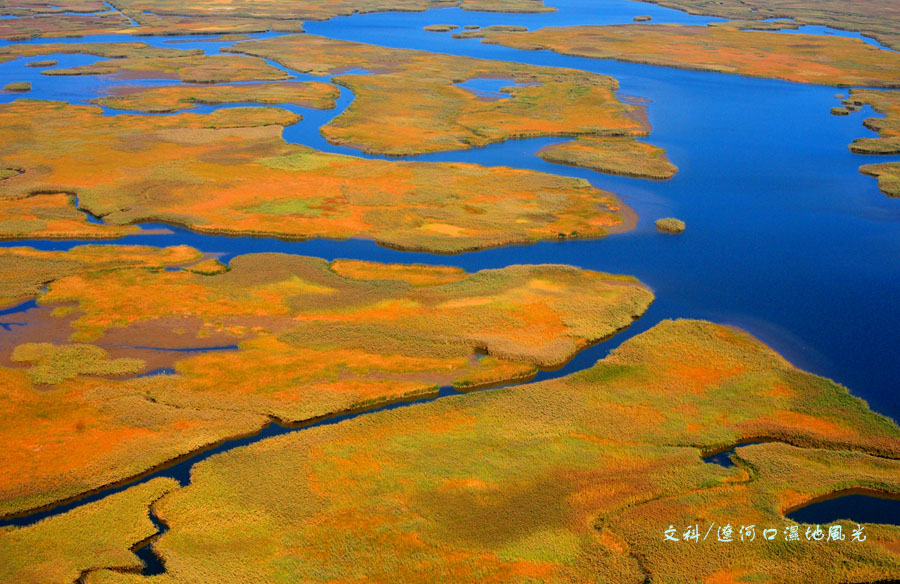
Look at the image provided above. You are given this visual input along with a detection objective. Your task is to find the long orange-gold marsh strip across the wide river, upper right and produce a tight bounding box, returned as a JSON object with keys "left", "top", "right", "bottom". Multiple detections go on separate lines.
{"left": 464, "top": 24, "right": 900, "bottom": 87}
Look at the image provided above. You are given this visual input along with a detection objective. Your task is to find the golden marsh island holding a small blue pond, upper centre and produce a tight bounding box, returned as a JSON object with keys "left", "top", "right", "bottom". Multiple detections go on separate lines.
{"left": 228, "top": 35, "right": 649, "bottom": 156}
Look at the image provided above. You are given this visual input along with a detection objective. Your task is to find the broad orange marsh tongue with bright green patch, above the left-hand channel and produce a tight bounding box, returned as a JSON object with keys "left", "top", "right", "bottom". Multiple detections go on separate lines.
{"left": 0, "top": 100, "right": 631, "bottom": 253}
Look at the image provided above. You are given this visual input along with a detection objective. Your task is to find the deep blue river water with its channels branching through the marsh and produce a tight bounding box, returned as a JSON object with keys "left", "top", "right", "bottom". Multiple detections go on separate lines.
{"left": 0, "top": 0, "right": 900, "bottom": 574}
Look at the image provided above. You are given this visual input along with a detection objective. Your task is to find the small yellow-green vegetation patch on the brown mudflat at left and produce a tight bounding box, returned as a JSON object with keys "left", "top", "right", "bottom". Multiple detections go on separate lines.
{"left": 10, "top": 343, "right": 144, "bottom": 385}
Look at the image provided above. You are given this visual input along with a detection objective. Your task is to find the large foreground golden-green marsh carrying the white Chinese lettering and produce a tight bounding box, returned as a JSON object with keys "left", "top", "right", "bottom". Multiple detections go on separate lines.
{"left": 74, "top": 321, "right": 900, "bottom": 584}
